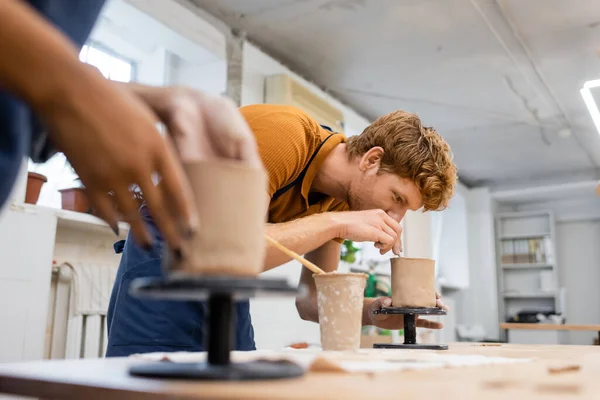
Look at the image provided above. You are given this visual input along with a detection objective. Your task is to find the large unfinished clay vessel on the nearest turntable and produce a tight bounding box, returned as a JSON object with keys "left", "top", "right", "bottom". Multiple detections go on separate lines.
{"left": 166, "top": 160, "right": 268, "bottom": 277}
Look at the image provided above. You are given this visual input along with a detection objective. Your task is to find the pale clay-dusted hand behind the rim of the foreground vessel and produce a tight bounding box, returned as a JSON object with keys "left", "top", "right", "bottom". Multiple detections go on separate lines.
{"left": 127, "top": 84, "right": 263, "bottom": 168}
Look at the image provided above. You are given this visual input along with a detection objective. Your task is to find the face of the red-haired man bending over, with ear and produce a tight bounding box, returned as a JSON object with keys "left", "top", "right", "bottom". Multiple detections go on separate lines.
{"left": 348, "top": 149, "right": 423, "bottom": 222}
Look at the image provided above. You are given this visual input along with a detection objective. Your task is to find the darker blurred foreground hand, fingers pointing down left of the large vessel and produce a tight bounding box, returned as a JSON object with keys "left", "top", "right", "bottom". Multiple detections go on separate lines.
{"left": 39, "top": 69, "right": 198, "bottom": 250}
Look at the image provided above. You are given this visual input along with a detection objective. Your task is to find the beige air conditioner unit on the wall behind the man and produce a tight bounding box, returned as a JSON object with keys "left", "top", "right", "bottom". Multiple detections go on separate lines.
{"left": 265, "top": 74, "right": 344, "bottom": 133}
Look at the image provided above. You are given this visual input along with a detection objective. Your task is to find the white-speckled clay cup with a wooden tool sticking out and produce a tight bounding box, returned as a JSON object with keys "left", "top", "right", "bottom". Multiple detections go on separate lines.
{"left": 313, "top": 273, "right": 367, "bottom": 350}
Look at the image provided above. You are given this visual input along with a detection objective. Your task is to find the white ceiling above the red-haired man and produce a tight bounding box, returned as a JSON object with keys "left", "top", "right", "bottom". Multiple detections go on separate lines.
{"left": 190, "top": 0, "right": 600, "bottom": 187}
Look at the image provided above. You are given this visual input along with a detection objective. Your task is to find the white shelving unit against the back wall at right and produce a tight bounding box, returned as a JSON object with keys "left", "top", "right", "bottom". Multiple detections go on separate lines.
{"left": 496, "top": 211, "right": 565, "bottom": 339}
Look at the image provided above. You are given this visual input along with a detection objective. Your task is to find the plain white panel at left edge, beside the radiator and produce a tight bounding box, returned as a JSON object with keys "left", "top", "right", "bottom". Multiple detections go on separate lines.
{"left": 0, "top": 206, "right": 56, "bottom": 362}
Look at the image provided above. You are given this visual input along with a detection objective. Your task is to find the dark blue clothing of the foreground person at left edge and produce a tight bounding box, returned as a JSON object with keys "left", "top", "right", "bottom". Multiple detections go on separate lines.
{"left": 0, "top": 0, "right": 105, "bottom": 208}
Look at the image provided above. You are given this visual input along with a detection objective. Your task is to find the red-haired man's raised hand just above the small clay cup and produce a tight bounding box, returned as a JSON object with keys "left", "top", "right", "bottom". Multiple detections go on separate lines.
{"left": 330, "top": 210, "right": 402, "bottom": 255}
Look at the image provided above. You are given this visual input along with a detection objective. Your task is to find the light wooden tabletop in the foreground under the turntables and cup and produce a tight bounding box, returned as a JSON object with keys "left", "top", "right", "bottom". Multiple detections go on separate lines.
{"left": 0, "top": 343, "right": 600, "bottom": 400}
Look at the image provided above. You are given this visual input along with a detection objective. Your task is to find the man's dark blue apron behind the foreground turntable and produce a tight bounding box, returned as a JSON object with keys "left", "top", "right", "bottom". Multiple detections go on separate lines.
{"left": 106, "top": 206, "right": 256, "bottom": 357}
